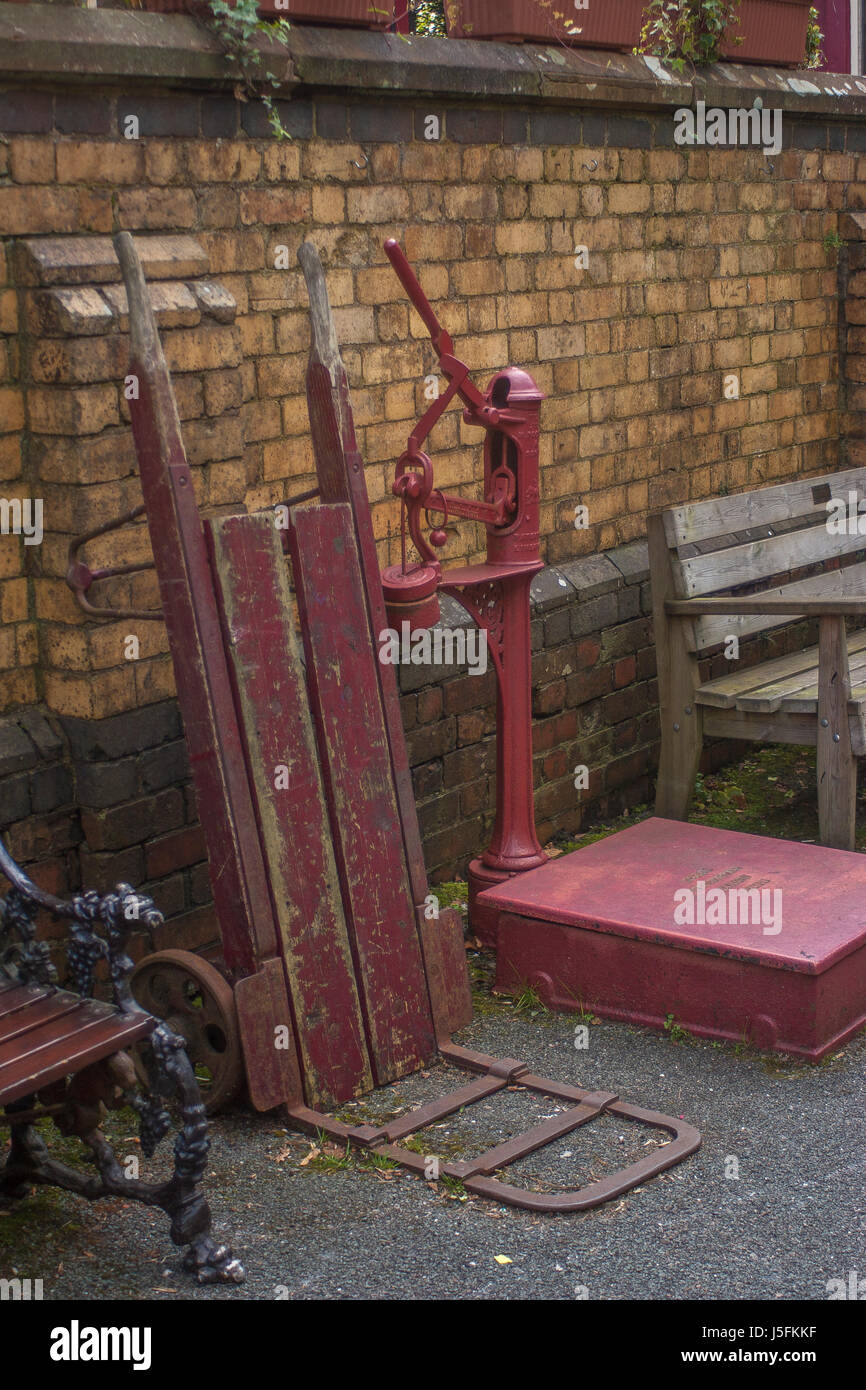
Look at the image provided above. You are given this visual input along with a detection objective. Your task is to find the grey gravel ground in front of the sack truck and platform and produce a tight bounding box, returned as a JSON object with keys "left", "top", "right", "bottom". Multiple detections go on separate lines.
{"left": 0, "top": 967, "right": 866, "bottom": 1300}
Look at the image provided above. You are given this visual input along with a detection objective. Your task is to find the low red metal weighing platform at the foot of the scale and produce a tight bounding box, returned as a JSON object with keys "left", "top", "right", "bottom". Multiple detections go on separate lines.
{"left": 481, "top": 817, "right": 866, "bottom": 1062}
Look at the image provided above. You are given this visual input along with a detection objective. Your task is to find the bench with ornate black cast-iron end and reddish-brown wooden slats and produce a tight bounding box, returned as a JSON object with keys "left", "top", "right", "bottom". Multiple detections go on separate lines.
{"left": 0, "top": 842, "right": 243, "bottom": 1284}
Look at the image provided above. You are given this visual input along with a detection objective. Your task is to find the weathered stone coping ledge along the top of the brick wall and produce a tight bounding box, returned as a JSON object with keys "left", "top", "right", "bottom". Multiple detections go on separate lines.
{"left": 0, "top": 3, "right": 866, "bottom": 118}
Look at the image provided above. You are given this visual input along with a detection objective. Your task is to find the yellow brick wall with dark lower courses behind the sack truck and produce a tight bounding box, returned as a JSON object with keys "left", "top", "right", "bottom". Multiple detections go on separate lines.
{"left": 0, "top": 4, "right": 866, "bottom": 928}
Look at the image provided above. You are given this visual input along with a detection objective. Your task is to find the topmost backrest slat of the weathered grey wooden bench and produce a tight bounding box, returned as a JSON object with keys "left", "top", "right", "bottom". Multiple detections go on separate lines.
{"left": 664, "top": 467, "right": 866, "bottom": 549}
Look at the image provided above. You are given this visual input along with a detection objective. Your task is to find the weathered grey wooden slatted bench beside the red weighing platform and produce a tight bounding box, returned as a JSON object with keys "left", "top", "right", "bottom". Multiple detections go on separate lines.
{"left": 648, "top": 468, "right": 866, "bottom": 849}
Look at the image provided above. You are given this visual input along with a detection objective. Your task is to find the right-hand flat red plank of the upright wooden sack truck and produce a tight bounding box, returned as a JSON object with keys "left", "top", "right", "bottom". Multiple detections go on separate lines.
{"left": 289, "top": 505, "right": 436, "bottom": 1084}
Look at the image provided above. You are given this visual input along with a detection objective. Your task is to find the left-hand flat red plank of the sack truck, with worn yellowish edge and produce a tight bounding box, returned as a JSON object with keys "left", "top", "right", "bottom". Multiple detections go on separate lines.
{"left": 209, "top": 514, "right": 373, "bottom": 1105}
